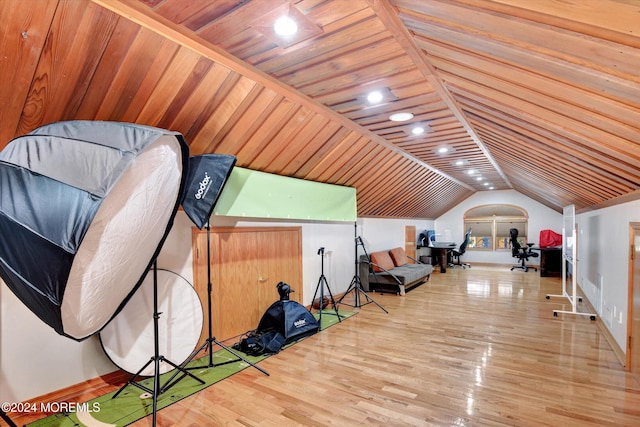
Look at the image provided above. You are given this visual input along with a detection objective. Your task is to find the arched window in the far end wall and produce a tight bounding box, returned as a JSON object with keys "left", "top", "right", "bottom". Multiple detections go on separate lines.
{"left": 464, "top": 204, "right": 529, "bottom": 251}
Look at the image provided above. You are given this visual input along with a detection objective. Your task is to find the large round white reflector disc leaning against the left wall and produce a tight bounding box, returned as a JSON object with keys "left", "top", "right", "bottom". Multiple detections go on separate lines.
{"left": 100, "top": 269, "right": 203, "bottom": 376}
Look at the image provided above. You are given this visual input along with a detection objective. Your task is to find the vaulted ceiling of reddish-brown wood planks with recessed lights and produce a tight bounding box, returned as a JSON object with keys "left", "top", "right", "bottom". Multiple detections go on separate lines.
{"left": 0, "top": 0, "right": 640, "bottom": 218}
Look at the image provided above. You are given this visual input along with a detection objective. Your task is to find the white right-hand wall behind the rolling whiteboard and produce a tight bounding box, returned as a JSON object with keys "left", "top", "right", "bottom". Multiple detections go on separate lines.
{"left": 576, "top": 200, "right": 640, "bottom": 351}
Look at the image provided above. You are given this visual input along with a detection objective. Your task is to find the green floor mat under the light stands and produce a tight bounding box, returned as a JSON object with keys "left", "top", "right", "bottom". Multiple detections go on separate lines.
{"left": 27, "top": 310, "right": 356, "bottom": 427}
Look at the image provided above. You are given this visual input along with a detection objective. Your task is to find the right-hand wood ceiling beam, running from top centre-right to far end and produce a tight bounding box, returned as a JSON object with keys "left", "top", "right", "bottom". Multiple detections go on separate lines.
{"left": 367, "top": 0, "right": 513, "bottom": 188}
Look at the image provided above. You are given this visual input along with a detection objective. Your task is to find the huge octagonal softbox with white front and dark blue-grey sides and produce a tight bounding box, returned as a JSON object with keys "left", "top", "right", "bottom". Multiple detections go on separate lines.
{"left": 0, "top": 121, "right": 189, "bottom": 341}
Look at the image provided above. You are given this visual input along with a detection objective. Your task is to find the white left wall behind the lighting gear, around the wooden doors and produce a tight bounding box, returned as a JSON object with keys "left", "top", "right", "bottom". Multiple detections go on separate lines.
{"left": 0, "top": 211, "right": 356, "bottom": 402}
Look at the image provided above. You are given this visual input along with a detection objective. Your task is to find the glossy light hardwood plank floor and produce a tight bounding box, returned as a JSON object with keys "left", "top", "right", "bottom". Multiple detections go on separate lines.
{"left": 10, "top": 266, "right": 640, "bottom": 427}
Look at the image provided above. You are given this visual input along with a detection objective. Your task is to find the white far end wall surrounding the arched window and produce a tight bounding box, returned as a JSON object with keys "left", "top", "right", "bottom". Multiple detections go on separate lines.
{"left": 435, "top": 190, "right": 562, "bottom": 265}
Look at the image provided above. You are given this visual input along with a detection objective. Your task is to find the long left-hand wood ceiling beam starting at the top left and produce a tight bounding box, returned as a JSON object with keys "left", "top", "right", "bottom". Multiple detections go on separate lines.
{"left": 90, "top": 0, "right": 476, "bottom": 191}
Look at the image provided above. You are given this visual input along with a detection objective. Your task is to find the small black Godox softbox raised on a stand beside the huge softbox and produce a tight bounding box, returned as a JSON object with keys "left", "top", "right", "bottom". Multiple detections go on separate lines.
{"left": 182, "top": 154, "right": 236, "bottom": 229}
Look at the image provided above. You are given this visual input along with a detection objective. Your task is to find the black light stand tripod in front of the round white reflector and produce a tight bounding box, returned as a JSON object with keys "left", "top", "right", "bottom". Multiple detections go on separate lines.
{"left": 111, "top": 260, "right": 204, "bottom": 426}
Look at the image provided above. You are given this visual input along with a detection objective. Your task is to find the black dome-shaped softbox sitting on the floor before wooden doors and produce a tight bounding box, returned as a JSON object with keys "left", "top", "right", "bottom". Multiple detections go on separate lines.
{"left": 257, "top": 300, "right": 320, "bottom": 343}
